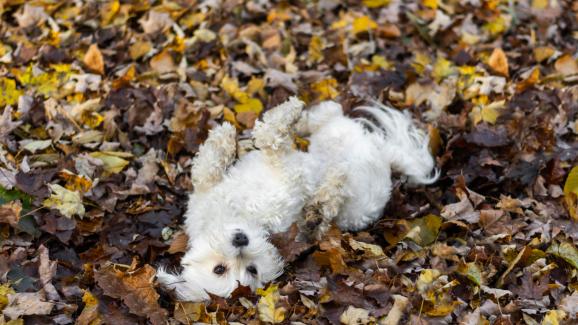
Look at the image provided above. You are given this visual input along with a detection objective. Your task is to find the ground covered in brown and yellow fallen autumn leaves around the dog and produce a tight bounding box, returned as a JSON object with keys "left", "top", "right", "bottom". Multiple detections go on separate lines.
{"left": 0, "top": 0, "right": 578, "bottom": 325}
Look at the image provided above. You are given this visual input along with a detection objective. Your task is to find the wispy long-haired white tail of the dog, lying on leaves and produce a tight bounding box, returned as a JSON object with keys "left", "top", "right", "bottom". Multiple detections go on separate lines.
{"left": 356, "top": 103, "right": 439, "bottom": 184}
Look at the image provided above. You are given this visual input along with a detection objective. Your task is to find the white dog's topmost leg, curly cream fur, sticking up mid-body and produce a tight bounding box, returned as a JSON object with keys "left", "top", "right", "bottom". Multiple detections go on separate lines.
{"left": 253, "top": 97, "right": 304, "bottom": 156}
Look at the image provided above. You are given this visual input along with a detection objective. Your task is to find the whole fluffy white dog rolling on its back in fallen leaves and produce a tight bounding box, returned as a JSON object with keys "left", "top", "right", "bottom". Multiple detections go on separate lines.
{"left": 157, "top": 97, "right": 438, "bottom": 301}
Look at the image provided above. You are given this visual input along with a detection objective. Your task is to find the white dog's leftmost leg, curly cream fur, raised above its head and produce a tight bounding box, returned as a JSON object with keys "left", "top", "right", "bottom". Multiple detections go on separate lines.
{"left": 191, "top": 122, "right": 237, "bottom": 192}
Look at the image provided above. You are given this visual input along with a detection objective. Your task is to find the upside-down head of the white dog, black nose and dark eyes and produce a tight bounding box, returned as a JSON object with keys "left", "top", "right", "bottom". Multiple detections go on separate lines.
{"left": 158, "top": 224, "right": 283, "bottom": 301}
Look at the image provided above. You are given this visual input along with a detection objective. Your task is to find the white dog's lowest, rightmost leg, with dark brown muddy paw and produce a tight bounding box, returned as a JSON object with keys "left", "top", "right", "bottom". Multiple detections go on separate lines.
{"left": 299, "top": 167, "right": 346, "bottom": 239}
